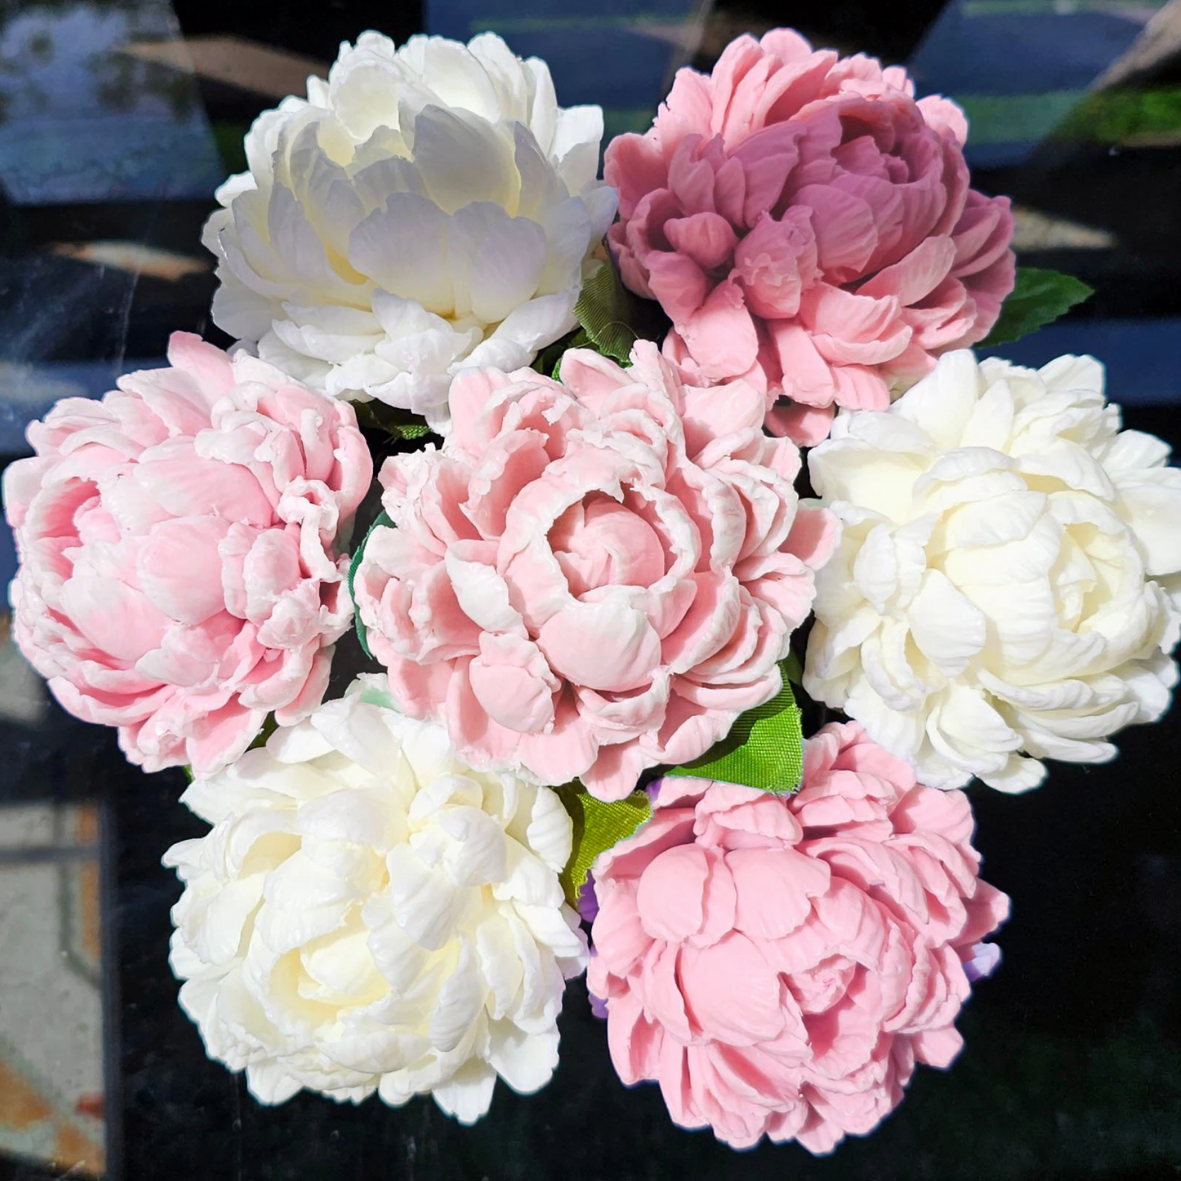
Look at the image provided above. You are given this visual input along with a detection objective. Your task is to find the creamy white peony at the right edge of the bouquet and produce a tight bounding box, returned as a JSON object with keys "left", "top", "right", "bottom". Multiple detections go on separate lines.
{"left": 804, "top": 352, "right": 1181, "bottom": 791}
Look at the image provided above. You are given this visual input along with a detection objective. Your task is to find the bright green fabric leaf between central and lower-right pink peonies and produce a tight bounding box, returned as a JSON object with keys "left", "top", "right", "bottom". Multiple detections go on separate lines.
{"left": 665, "top": 661, "right": 804, "bottom": 792}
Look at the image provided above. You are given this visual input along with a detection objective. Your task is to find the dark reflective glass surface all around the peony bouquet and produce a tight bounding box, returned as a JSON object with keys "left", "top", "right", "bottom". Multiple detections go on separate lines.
{"left": 0, "top": 0, "right": 1181, "bottom": 1181}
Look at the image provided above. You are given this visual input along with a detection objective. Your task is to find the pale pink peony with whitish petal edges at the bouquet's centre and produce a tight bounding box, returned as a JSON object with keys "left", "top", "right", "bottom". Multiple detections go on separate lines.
{"left": 353, "top": 341, "right": 835, "bottom": 800}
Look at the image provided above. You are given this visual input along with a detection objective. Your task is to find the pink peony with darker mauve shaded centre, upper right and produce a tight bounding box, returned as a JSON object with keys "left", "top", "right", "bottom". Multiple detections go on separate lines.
{"left": 605, "top": 28, "right": 1014, "bottom": 444}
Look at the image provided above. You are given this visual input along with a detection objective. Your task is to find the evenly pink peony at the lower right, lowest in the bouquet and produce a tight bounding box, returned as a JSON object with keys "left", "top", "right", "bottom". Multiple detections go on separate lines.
{"left": 587, "top": 724, "right": 1009, "bottom": 1153}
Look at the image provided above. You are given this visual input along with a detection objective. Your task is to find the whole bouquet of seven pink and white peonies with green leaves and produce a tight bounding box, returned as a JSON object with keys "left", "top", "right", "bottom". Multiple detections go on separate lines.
{"left": 4, "top": 30, "right": 1181, "bottom": 1153}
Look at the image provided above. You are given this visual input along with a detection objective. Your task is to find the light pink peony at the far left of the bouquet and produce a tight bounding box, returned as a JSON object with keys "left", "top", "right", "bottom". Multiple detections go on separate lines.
{"left": 4, "top": 332, "right": 373, "bottom": 776}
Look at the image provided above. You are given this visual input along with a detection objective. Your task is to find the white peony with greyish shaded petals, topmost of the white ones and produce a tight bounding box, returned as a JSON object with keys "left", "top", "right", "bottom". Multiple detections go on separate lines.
{"left": 204, "top": 33, "right": 615, "bottom": 430}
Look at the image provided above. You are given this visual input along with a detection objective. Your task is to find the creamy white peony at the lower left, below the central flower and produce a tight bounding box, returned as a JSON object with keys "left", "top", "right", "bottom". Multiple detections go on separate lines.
{"left": 164, "top": 678, "right": 587, "bottom": 1123}
